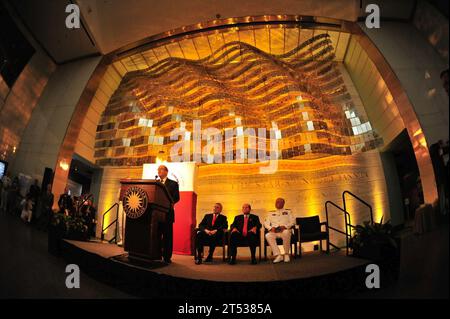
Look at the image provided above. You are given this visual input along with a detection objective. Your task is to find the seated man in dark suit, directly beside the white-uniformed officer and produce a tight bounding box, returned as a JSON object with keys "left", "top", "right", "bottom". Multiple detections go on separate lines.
{"left": 229, "top": 204, "right": 261, "bottom": 265}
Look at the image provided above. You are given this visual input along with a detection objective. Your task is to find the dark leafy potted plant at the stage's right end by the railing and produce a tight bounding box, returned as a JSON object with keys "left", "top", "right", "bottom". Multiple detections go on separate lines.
{"left": 350, "top": 218, "right": 398, "bottom": 260}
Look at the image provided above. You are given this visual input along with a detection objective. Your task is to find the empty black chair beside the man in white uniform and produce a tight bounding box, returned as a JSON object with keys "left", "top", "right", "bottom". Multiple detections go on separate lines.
{"left": 296, "top": 216, "right": 330, "bottom": 257}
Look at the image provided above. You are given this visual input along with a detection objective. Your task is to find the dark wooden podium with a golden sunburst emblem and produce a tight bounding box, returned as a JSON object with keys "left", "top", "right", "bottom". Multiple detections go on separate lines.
{"left": 120, "top": 179, "right": 172, "bottom": 260}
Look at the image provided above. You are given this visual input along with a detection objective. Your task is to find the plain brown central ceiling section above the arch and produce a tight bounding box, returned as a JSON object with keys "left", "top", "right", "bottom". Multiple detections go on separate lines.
{"left": 77, "top": 0, "right": 359, "bottom": 53}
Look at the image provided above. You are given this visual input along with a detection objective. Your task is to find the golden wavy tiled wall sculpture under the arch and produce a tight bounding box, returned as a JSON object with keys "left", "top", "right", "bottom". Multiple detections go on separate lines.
{"left": 95, "top": 27, "right": 382, "bottom": 166}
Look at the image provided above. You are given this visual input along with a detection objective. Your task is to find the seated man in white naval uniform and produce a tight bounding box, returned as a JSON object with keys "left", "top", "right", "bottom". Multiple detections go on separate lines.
{"left": 264, "top": 198, "right": 295, "bottom": 264}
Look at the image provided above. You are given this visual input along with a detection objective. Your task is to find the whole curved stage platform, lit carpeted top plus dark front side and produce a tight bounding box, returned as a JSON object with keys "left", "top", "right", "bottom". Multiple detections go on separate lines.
{"left": 61, "top": 240, "right": 380, "bottom": 298}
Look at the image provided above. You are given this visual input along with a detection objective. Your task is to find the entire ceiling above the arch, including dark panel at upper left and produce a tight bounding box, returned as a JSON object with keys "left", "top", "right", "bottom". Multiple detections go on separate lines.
{"left": 8, "top": 0, "right": 415, "bottom": 63}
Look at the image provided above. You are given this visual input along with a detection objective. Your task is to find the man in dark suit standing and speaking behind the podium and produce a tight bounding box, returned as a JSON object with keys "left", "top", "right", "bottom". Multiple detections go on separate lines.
{"left": 158, "top": 165, "right": 180, "bottom": 263}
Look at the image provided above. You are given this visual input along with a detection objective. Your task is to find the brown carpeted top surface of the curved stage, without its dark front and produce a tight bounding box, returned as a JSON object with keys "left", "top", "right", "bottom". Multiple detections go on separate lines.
{"left": 68, "top": 240, "right": 368, "bottom": 282}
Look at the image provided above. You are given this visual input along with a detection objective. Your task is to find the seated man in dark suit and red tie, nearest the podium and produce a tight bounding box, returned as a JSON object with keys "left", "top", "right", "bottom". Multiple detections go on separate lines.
{"left": 195, "top": 203, "right": 228, "bottom": 265}
